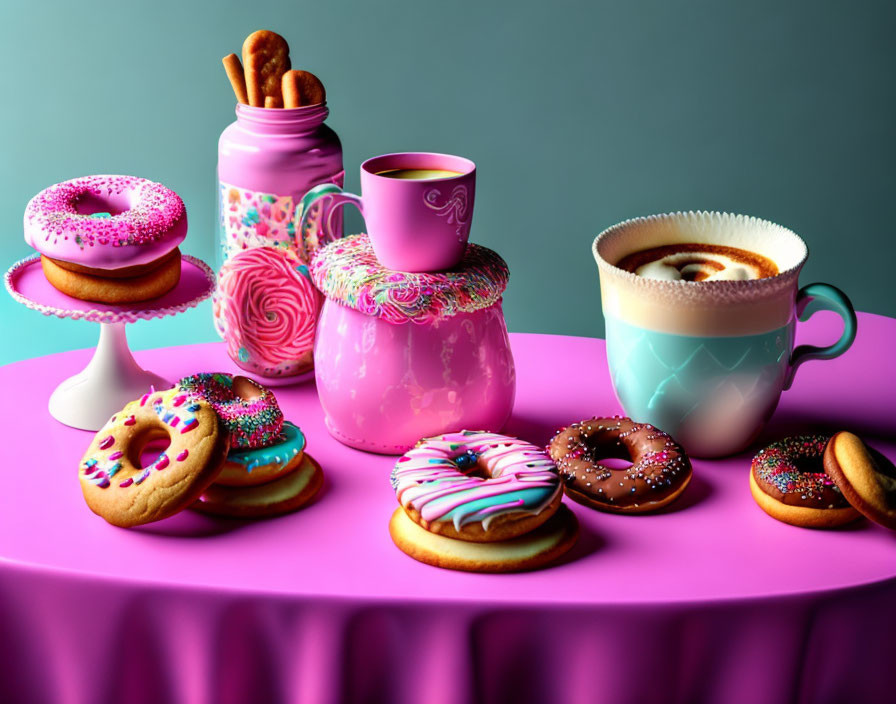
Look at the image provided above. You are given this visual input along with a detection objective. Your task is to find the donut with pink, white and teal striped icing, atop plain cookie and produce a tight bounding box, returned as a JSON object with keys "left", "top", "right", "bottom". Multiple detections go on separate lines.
{"left": 392, "top": 430, "right": 563, "bottom": 542}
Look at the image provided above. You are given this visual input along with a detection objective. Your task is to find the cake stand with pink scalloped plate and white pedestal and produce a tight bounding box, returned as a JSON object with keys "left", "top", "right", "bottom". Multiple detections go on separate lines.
{"left": 5, "top": 255, "right": 215, "bottom": 430}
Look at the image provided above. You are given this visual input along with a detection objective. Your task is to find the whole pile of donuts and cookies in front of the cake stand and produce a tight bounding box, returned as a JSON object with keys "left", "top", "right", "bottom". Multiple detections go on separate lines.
{"left": 78, "top": 373, "right": 323, "bottom": 528}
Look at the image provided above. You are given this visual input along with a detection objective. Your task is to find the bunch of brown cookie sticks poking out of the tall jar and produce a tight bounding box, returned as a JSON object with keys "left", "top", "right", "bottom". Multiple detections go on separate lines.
{"left": 222, "top": 29, "right": 327, "bottom": 108}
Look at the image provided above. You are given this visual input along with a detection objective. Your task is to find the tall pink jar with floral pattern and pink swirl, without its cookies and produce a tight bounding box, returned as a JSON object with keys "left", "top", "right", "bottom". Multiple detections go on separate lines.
{"left": 213, "top": 104, "right": 345, "bottom": 379}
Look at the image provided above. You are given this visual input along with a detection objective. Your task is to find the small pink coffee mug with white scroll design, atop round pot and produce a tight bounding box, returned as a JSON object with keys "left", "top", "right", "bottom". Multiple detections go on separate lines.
{"left": 297, "top": 152, "right": 476, "bottom": 272}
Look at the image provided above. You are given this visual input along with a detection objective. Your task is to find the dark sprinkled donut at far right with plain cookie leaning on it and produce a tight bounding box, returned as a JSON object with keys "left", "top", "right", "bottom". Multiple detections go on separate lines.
{"left": 750, "top": 435, "right": 860, "bottom": 528}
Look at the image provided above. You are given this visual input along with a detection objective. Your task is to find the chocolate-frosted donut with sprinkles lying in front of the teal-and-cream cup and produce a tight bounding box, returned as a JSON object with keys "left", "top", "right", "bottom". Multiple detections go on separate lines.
{"left": 548, "top": 416, "right": 692, "bottom": 513}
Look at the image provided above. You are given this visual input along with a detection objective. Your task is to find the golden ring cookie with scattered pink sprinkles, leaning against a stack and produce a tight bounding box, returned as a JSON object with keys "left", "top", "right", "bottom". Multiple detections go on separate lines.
{"left": 78, "top": 386, "right": 230, "bottom": 528}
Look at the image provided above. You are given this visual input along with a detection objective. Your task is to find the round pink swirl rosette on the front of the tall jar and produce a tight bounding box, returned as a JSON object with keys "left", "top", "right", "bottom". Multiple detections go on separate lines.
{"left": 216, "top": 247, "right": 321, "bottom": 377}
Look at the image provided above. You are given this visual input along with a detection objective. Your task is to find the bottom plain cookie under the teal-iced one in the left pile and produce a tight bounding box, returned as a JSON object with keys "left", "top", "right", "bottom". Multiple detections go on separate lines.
{"left": 190, "top": 452, "right": 324, "bottom": 518}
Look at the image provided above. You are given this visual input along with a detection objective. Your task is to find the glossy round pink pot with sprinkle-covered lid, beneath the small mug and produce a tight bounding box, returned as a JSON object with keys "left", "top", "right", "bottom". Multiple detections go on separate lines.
{"left": 311, "top": 235, "right": 516, "bottom": 454}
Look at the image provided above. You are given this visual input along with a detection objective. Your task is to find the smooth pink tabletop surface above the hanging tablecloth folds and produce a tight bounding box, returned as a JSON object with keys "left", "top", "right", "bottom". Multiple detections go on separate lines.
{"left": 0, "top": 315, "right": 896, "bottom": 604}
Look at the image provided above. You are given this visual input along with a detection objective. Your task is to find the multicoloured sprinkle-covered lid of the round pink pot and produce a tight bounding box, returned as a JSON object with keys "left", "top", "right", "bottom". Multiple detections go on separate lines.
{"left": 311, "top": 235, "right": 510, "bottom": 324}
